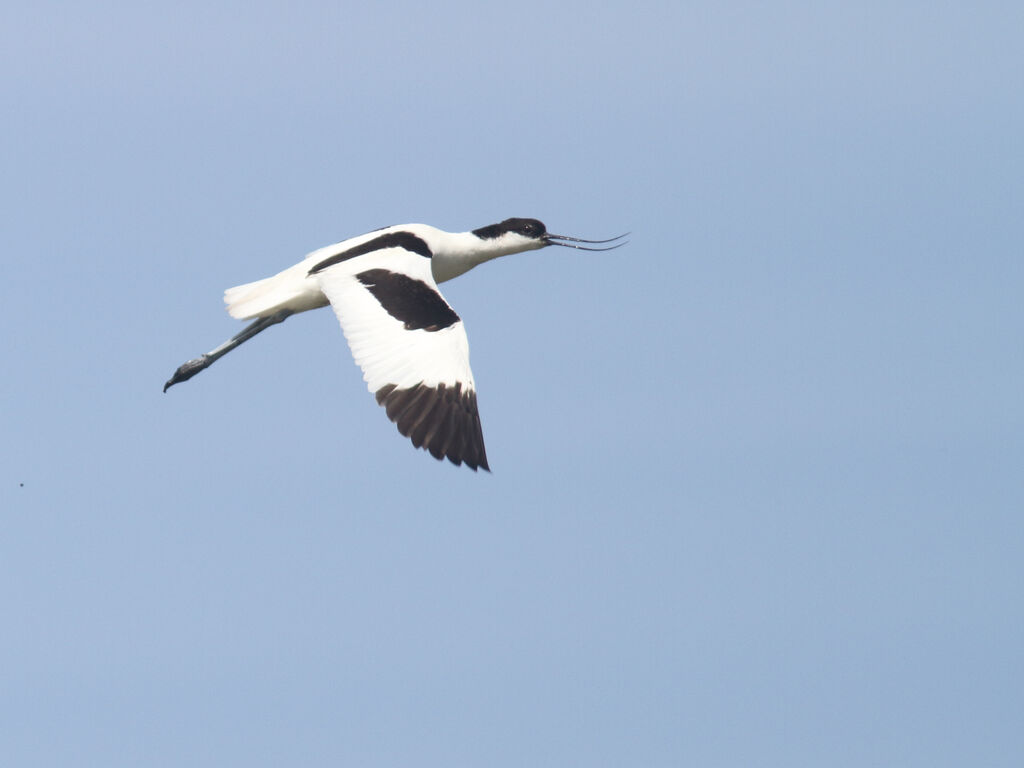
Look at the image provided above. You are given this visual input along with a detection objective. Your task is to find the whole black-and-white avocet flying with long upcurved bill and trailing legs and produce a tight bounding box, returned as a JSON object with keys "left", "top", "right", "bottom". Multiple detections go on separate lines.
{"left": 164, "top": 218, "right": 625, "bottom": 470}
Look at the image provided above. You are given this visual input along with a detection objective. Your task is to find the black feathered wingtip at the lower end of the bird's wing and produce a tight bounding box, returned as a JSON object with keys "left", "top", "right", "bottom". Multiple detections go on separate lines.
{"left": 377, "top": 382, "right": 490, "bottom": 472}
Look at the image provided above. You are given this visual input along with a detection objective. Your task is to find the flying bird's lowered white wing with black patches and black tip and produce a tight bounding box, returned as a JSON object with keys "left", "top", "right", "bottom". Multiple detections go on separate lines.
{"left": 310, "top": 238, "right": 489, "bottom": 470}
